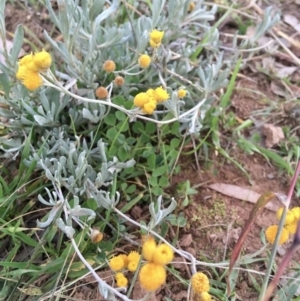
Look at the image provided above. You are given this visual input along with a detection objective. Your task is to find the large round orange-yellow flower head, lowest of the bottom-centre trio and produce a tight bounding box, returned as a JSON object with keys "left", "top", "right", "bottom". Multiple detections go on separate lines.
{"left": 139, "top": 262, "right": 167, "bottom": 292}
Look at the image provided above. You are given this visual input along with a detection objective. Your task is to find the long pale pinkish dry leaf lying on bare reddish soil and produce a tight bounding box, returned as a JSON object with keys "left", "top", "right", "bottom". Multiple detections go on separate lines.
{"left": 208, "top": 183, "right": 280, "bottom": 211}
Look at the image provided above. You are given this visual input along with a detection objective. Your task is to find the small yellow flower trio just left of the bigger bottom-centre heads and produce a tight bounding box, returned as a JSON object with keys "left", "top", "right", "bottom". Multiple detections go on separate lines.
{"left": 109, "top": 251, "right": 141, "bottom": 287}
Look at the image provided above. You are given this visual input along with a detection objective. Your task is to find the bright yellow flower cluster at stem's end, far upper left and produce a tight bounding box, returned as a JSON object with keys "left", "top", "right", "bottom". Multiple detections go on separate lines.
{"left": 16, "top": 50, "right": 52, "bottom": 91}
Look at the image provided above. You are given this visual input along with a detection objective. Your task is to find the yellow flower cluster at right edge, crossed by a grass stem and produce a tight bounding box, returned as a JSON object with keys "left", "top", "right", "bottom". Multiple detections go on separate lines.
{"left": 265, "top": 207, "right": 300, "bottom": 245}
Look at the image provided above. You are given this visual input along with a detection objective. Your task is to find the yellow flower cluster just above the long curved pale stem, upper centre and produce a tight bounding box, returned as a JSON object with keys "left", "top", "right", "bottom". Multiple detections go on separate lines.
{"left": 133, "top": 87, "right": 170, "bottom": 115}
